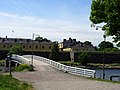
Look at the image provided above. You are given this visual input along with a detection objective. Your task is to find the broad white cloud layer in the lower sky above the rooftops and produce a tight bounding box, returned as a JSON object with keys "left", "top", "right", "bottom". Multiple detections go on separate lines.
{"left": 0, "top": 12, "right": 112, "bottom": 45}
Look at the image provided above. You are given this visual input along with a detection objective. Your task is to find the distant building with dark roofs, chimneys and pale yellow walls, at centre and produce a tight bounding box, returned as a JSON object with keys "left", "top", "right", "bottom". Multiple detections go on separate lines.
{"left": 59, "top": 38, "right": 94, "bottom": 52}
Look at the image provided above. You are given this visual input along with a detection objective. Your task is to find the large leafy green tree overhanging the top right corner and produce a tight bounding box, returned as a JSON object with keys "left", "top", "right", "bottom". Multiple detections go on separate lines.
{"left": 90, "top": 0, "right": 120, "bottom": 42}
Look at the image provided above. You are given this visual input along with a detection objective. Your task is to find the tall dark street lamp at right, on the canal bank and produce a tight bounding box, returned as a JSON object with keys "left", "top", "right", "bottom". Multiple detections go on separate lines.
{"left": 91, "top": 24, "right": 106, "bottom": 79}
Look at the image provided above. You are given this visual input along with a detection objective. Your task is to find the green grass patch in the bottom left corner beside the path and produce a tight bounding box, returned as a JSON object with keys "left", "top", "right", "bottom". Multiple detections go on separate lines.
{"left": 0, "top": 75, "right": 32, "bottom": 90}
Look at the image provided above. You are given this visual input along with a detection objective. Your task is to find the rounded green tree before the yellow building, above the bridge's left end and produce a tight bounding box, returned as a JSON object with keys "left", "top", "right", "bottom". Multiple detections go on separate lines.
{"left": 8, "top": 45, "right": 23, "bottom": 55}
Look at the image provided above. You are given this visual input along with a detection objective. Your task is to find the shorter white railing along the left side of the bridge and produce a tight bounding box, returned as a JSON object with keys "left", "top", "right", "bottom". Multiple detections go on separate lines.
{"left": 11, "top": 54, "right": 31, "bottom": 64}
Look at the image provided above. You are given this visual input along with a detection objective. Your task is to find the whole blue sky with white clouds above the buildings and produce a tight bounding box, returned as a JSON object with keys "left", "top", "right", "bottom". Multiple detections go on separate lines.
{"left": 0, "top": 0, "right": 112, "bottom": 46}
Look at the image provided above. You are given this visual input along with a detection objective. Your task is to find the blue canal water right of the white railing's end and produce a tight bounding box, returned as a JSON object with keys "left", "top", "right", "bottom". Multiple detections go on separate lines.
{"left": 95, "top": 69, "right": 120, "bottom": 82}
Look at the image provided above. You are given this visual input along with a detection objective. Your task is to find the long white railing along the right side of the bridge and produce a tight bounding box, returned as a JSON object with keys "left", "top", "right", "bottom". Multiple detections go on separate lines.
{"left": 24, "top": 55, "right": 95, "bottom": 78}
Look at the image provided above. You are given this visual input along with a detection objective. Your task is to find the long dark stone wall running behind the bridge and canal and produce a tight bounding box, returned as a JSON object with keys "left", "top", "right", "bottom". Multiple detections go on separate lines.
{"left": 0, "top": 50, "right": 120, "bottom": 63}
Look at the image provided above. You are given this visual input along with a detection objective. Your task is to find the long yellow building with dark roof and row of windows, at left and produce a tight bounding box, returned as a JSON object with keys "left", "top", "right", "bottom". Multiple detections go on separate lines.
{"left": 0, "top": 36, "right": 52, "bottom": 52}
